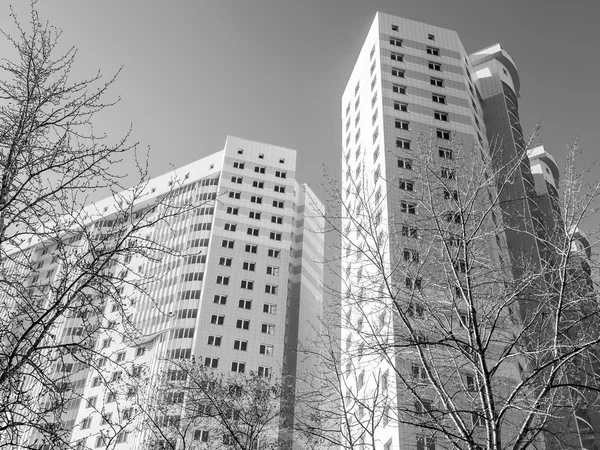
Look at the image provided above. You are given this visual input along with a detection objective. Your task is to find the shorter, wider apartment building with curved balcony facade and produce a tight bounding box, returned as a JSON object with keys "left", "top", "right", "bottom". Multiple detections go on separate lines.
{"left": 9, "top": 136, "right": 324, "bottom": 449}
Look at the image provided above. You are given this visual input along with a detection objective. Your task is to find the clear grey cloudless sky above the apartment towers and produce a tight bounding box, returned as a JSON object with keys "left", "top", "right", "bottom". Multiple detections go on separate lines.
{"left": 0, "top": 0, "right": 600, "bottom": 204}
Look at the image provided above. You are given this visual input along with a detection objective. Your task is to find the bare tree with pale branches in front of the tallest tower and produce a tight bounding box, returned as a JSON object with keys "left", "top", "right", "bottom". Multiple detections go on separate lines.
{"left": 305, "top": 135, "right": 600, "bottom": 450}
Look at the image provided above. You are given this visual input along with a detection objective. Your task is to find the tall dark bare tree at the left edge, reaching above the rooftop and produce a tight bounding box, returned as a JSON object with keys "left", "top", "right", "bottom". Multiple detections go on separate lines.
{"left": 0, "top": 2, "right": 206, "bottom": 448}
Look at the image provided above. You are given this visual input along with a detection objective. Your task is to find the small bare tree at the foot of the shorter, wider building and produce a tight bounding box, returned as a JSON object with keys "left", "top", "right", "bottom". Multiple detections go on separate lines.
{"left": 140, "top": 360, "right": 283, "bottom": 450}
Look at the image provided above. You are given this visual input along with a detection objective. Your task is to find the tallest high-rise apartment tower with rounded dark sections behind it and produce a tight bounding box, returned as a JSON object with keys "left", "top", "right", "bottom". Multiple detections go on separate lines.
{"left": 341, "top": 13, "right": 600, "bottom": 450}
